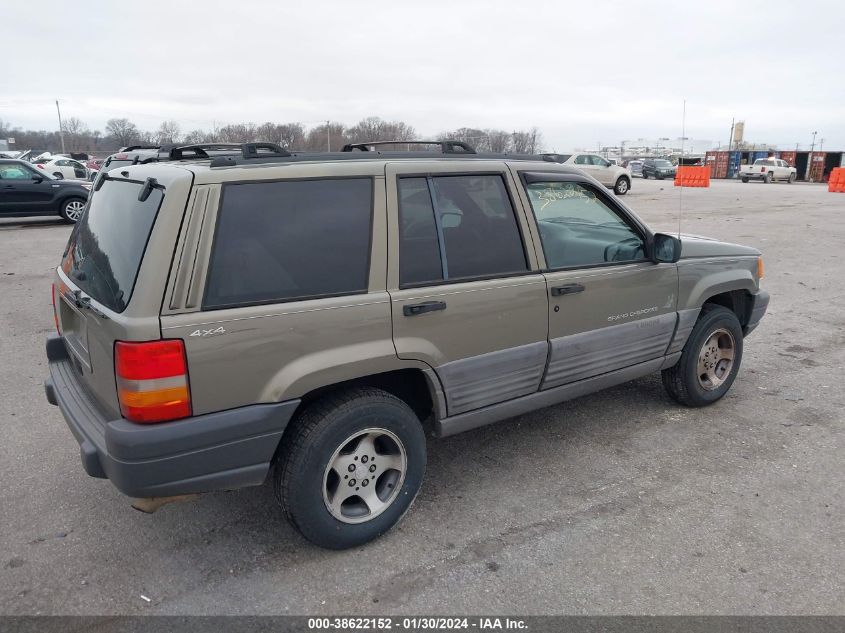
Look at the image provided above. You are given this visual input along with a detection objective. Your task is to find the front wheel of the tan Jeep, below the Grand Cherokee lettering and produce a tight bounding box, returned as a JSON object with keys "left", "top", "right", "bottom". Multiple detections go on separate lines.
{"left": 661, "top": 304, "right": 742, "bottom": 407}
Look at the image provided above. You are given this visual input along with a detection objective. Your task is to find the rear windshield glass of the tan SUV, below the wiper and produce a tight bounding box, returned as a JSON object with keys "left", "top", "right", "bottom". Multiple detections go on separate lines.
{"left": 62, "top": 180, "right": 164, "bottom": 312}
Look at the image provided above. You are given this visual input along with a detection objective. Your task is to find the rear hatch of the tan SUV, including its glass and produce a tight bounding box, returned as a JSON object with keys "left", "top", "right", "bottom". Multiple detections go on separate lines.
{"left": 53, "top": 165, "right": 193, "bottom": 419}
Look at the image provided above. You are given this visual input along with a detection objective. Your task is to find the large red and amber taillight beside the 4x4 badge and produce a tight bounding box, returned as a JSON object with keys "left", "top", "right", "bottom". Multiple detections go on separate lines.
{"left": 114, "top": 339, "right": 191, "bottom": 424}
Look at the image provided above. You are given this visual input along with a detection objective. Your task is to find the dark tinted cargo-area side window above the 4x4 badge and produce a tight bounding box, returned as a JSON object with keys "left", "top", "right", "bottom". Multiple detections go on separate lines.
{"left": 203, "top": 178, "right": 373, "bottom": 309}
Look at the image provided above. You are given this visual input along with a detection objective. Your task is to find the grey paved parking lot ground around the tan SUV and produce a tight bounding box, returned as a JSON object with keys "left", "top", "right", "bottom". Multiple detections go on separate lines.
{"left": 0, "top": 179, "right": 845, "bottom": 615}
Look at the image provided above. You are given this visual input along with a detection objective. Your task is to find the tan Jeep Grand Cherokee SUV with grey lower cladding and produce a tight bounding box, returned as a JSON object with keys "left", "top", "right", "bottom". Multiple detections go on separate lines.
{"left": 45, "top": 143, "right": 768, "bottom": 548}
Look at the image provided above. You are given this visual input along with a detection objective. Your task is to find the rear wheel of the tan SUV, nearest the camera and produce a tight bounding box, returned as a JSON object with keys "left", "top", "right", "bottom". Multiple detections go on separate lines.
{"left": 274, "top": 388, "right": 426, "bottom": 549}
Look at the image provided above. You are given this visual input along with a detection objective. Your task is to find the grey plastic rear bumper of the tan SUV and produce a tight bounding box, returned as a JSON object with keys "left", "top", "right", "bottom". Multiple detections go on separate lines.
{"left": 44, "top": 335, "right": 299, "bottom": 497}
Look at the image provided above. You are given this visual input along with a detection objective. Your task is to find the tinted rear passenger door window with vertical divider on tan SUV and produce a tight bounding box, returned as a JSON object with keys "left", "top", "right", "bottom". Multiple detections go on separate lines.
{"left": 399, "top": 175, "right": 528, "bottom": 287}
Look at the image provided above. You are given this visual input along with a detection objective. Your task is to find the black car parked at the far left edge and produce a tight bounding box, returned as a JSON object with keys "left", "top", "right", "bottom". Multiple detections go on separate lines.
{"left": 0, "top": 159, "right": 91, "bottom": 222}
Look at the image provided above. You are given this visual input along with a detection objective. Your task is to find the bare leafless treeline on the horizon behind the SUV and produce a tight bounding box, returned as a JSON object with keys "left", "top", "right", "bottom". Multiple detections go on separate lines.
{"left": 0, "top": 117, "right": 542, "bottom": 154}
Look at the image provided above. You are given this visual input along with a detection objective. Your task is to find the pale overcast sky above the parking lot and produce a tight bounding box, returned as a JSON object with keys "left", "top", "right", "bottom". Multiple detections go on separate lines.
{"left": 0, "top": 0, "right": 845, "bottom": 151}
